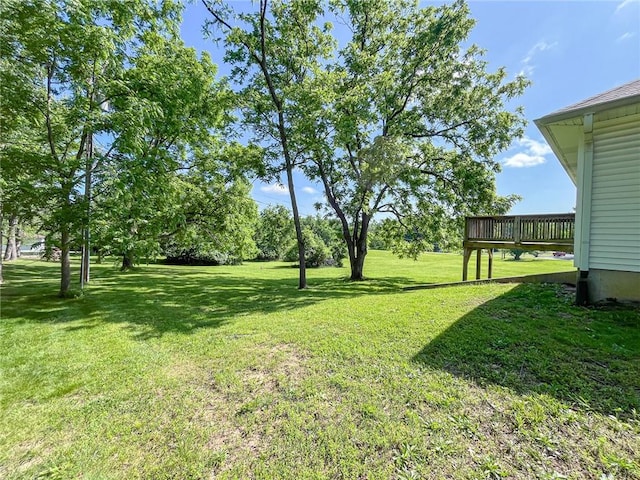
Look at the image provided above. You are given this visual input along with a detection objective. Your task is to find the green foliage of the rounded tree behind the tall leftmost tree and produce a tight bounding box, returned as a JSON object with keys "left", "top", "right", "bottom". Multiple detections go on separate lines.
{"left": 96, "top": 31, "right": 245, "bottom": 268}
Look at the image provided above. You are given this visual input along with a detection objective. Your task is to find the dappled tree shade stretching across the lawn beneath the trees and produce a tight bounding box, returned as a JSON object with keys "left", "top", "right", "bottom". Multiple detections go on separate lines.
{"left": 2, "top": 262, "right": 410, "bottom": 340}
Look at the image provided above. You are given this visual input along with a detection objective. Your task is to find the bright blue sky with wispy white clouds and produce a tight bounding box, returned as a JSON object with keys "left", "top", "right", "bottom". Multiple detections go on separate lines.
{"left": 182, "top": 0, "right": 640, "bottom": 214}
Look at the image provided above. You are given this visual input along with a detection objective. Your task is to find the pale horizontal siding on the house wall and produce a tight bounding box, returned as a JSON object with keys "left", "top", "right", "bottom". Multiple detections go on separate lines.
{"left": 589, "top": 115, "right": 640, "bottom": 272}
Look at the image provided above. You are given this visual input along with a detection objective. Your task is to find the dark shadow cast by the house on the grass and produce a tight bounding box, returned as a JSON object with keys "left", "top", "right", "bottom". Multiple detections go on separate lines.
{"left": 413, "top": 284, "right": 640, "bottom": 418}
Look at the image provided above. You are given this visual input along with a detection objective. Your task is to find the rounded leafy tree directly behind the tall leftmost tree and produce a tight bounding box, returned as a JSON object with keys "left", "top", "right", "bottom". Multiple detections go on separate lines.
{"left": 90, "top": 36, "right": 244, "bottom": 269}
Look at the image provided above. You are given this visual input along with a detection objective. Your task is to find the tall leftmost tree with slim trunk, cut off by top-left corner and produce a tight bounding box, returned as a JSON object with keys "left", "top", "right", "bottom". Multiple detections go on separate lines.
{"left": 0, "top": 0, "right": 188, "bottom": 296}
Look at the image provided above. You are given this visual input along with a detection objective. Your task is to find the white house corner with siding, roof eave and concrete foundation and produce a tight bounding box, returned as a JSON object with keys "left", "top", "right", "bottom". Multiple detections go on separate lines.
{"left": 535, "top": 79, "right": 640, "bottom": 303}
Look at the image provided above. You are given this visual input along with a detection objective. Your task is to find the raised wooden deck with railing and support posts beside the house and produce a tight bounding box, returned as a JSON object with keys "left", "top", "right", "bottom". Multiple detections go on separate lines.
{"left": 462, "top": 213, "right": 576, "bottom": 281}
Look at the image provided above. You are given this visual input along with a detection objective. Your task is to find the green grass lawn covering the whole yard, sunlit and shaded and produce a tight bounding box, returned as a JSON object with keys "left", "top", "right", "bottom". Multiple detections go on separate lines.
{"left": 0, "top": 251, "right": 640, "bottom": 479}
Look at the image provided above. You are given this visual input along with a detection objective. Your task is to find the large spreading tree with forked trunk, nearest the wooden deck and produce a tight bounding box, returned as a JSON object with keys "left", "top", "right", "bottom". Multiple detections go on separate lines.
{"left": 304, "top": 0, "right": 527, "bottom": 280}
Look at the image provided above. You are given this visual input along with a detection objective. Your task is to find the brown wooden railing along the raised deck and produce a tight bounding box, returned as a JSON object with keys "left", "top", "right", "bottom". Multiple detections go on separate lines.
{"left": 465, "top": 213, "right": 575, "bottom": 245}
